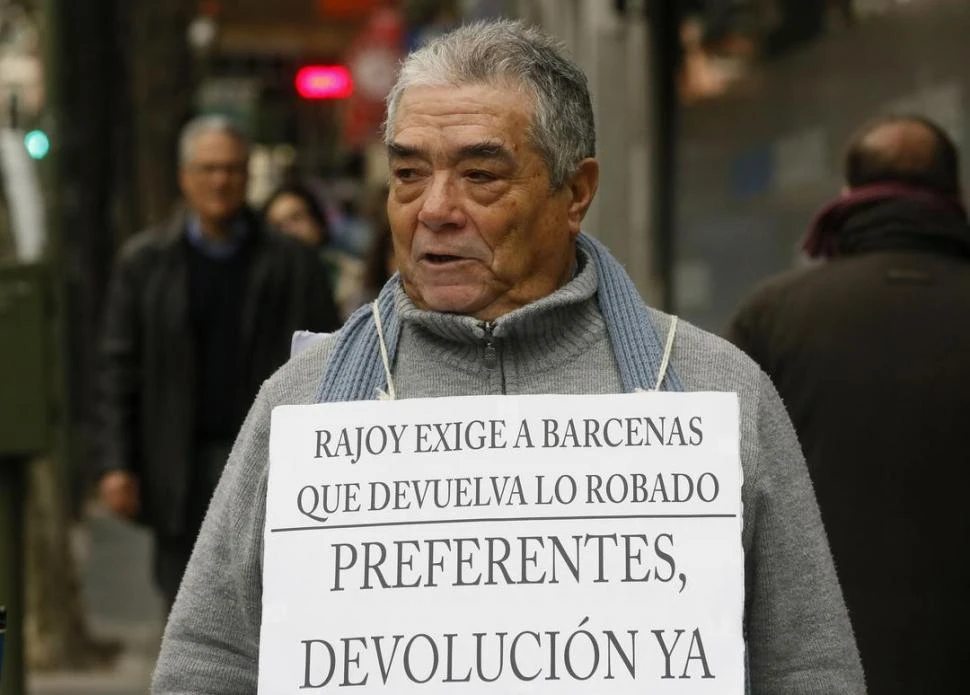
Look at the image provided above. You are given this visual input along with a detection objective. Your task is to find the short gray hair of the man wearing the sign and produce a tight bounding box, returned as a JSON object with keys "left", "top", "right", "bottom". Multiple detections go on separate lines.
{"left": 384, "top": 20, "right": 596, "bottom": 189}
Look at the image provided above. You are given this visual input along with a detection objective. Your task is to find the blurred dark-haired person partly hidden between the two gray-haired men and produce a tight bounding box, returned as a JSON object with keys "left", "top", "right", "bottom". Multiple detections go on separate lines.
{"left": 263, "top": 183, "right": 363, "bottom": 321}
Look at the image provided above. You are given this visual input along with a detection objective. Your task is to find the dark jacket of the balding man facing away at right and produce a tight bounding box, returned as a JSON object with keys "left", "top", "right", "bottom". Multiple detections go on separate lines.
{"left": 730, "top": 200, "right": 970, "bottom": 695}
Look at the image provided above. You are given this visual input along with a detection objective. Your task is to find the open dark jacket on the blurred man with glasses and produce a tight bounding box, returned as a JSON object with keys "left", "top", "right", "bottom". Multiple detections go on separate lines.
{"left": 95, "top": 205, "right": 338, "bottom": 535}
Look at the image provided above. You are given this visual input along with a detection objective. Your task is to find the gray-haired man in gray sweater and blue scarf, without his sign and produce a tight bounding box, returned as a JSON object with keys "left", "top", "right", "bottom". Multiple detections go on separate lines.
{"left": 154, "top": 22, "right": 864, "bottom": 694}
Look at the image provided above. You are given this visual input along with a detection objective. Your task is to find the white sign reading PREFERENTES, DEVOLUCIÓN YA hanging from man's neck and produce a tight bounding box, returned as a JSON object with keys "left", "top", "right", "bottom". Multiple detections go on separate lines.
{"left": 259, "top": 393, "right": 744, "bottom": 695}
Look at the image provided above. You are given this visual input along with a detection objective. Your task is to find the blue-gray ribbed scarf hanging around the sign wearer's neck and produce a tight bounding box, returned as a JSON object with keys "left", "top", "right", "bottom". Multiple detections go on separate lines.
{"left": 317, "top": 234, "right": 683, "bottom": 403}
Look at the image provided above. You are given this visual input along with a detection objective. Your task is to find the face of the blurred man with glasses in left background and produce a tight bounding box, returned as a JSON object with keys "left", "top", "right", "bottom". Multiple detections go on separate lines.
{"left": 179, "top": 130, "right": 248, "bottom": 224}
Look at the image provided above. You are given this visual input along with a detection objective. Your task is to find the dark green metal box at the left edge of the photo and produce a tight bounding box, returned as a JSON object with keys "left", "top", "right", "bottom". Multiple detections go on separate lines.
{"left": 0, "top": 265, "right": 52, "bottom": 459}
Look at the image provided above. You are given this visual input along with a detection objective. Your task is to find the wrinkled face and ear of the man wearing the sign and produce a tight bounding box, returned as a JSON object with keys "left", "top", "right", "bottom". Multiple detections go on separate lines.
{"left": 387, "top": 85, "right": 597, "bottom": 321}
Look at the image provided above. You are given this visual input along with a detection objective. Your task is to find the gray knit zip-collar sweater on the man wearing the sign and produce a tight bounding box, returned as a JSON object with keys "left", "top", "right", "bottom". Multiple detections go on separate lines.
{"left": 152, "top": 256, "right": 865, "bottom": 695}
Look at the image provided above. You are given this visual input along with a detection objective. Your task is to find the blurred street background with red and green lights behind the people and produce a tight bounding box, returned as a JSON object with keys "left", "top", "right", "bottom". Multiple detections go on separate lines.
{"left": 0, "top": 0, "right": 970, "bottom": 695}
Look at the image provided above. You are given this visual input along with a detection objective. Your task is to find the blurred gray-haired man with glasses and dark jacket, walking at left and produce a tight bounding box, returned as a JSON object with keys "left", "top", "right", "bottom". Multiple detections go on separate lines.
{"left": 97, "top": 116, "right": 338, "bottom": 606}
